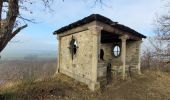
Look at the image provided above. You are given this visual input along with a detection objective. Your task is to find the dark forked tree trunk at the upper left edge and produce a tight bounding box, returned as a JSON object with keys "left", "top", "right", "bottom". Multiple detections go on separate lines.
{"left": 0, "top": 0, "right": 27, "bottom": 53}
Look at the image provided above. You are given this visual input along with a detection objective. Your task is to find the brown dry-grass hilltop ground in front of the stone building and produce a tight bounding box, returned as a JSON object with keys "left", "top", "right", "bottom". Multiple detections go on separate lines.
{"left": 0, "top": 71, "right": 170, "bottom": 100}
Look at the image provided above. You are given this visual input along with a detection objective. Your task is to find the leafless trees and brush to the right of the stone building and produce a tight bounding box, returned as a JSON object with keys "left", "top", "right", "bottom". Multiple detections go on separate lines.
{"left": 142, "top": 3, "right": 170, "bottom": 70}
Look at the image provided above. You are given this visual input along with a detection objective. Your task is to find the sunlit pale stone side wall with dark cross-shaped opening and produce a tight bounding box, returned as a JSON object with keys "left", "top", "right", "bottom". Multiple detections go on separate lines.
{"left": 60, "top": 30, "right": 93, "bottom": 84}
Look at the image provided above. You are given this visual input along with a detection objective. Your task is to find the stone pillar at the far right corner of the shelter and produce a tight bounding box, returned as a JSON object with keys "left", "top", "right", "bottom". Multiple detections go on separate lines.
{"left": 137, "top": 40, "right": 142, "bottom": 74}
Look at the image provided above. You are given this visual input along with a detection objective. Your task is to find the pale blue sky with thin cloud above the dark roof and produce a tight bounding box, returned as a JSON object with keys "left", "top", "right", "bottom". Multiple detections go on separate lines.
{"left": 2, "top": 0, "right": 166, "bottom": 58}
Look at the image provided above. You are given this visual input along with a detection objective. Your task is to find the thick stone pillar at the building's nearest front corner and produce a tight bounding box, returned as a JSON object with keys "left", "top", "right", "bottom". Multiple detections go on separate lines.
{"left": 88, "top": 25, "right": 103, "bottom": 91}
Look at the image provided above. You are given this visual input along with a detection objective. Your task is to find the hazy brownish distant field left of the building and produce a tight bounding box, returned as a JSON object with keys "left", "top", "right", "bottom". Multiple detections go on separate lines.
{"left": 0, "top": 59, "right": 57, "bottom": 80}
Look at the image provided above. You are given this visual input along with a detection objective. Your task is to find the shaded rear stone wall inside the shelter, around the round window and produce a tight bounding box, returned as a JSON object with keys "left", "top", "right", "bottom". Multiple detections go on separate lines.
{"left": 98, "top": 40, "right": 140, "bottom": 76}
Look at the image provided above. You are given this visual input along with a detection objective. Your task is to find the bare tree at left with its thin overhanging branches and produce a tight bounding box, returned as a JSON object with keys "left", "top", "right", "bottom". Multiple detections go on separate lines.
{"left": 0, "top": 0, "right": 103, "bottom": 56}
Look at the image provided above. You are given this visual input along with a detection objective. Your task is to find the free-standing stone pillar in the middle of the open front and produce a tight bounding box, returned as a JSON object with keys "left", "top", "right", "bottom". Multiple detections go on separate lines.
{"left": 120, "top": 35, "right": 128, "bottom": 79}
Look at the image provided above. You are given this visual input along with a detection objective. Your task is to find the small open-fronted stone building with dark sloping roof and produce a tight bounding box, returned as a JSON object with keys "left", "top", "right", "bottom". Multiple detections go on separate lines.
{"left": 53, "top": 14, "right": 146, "bottom": 90}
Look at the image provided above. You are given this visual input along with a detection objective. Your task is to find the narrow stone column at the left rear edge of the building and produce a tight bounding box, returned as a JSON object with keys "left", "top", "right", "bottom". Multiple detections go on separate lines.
{"left": 55, "top": 36, "right": 61, "bottom": 74}
